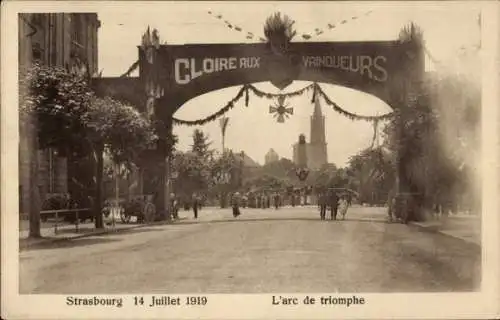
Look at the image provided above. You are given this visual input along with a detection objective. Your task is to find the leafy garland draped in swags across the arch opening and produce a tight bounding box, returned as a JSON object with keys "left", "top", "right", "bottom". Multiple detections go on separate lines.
{"left": 172, "top": 83, "right": 394, "bottom": 126}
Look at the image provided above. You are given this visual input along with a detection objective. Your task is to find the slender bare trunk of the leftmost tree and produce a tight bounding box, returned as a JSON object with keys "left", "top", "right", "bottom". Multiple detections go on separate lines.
{"left": 29, "top": 121, "right": 41, "bottom": 238}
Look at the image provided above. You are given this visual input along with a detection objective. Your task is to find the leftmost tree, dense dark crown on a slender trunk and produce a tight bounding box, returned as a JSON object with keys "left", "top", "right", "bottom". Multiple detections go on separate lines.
{"left": 19, "top": 64, "right": 90, "bottom": 237}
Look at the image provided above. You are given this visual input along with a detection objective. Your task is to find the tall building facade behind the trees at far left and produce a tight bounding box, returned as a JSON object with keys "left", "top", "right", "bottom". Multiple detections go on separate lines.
{"left": 18, "top": 13, "right": 100, "bottom": 214}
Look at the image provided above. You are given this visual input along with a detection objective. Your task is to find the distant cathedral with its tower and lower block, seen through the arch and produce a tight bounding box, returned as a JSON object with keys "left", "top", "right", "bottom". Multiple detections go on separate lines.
{"left": 293, "top": 99, "right": 328, "bottom": 169}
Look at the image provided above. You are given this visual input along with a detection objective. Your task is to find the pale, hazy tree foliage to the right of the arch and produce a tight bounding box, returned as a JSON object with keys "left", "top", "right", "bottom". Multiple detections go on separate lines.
{"left": 384, "top": 73, "right": 480, "bottom": 214}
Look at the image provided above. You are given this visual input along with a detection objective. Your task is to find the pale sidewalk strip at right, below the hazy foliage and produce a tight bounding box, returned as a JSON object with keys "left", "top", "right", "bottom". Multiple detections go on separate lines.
{"left": 409, "top": 214, "right": 481, "bottom": 246}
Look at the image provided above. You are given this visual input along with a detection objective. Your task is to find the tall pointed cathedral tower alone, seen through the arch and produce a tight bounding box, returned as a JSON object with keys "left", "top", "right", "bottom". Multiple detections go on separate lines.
{"left": 307, "top": 97, "right": 328, "bottom": 169}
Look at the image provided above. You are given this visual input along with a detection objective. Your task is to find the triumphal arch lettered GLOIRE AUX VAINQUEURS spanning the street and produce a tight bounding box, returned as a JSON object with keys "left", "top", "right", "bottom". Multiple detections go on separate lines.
{"left": 94, "top": 15, "right": 424, "bottom": 222}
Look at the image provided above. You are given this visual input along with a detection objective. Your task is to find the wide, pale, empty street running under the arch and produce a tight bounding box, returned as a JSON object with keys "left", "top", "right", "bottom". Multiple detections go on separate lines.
{"left": 20, "top": 207, "right": 481, "bottom": 294}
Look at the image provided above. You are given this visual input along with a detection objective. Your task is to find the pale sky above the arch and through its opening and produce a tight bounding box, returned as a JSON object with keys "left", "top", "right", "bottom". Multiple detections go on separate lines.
{"left": 96, "top": 2, "right": 480, "bottom": 166}
